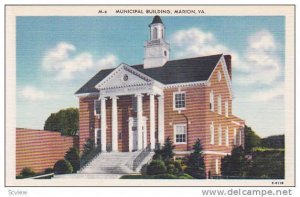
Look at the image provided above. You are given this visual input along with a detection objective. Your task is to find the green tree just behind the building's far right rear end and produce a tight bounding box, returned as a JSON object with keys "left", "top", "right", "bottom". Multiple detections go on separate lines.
{"left": 244, "top": 125, "right": 260, "bottom": 154}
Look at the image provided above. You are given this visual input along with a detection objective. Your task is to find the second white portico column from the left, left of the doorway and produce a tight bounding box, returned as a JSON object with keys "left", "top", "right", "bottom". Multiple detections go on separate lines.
{"left": 111, "top": 96, "right": 118, "bottom": 152}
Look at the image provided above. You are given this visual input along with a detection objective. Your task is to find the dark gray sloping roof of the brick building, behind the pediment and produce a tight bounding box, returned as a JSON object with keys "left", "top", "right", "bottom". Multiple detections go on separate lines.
{"left": 75, "top": 54, "right": 222, "bottom": 94}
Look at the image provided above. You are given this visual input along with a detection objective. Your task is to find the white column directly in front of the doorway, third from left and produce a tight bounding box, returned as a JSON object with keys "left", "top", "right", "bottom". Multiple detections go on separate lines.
{"left": 136, "top": 94, "right": 143, "bottom": 150}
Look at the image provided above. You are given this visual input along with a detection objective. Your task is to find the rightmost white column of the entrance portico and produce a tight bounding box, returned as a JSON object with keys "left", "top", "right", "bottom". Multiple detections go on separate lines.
{"left": 158, "top": 95, "right": 165, "bottom": 145}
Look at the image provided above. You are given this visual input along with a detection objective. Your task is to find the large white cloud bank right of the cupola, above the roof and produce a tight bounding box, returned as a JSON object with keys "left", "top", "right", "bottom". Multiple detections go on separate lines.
{"left": 171, "top": 28, "right": 283, "bottom": 101}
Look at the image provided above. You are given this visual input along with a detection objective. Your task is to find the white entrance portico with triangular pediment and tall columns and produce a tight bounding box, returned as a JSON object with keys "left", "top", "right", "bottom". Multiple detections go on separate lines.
{"left": 95, "top": 64, "right": 164, "bottom": 152}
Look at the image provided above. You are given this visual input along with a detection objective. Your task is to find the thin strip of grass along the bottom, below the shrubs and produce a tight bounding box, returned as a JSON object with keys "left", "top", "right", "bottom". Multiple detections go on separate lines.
{"left": 120, "top": 174, "right": 194, "bottom": 179}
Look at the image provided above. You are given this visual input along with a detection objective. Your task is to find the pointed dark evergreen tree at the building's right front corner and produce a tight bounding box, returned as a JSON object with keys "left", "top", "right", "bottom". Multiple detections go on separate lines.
{"left": 185, "top": 139, "right": 205, "bottom": 179}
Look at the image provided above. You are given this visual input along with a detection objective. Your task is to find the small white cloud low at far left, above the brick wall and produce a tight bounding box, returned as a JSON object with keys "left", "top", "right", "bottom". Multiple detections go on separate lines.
{"left": 21, "top": 86, "right": 58, "bottom": 101}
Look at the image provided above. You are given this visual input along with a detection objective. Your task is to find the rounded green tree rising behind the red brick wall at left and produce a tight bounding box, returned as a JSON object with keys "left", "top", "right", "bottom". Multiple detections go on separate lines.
{"left": 44, "top": 108, "right": 79, "bottom": 135}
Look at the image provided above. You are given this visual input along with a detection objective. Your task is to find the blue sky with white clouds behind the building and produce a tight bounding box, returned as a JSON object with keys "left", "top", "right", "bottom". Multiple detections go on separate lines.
{"left": 16, "top": 16, "right": 285, "bottom": 136}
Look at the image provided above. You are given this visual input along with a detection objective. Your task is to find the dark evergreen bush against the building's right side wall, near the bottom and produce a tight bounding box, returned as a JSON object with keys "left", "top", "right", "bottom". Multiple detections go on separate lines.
{"left": 221, "top": 146, "right": 249, "bottom": 177}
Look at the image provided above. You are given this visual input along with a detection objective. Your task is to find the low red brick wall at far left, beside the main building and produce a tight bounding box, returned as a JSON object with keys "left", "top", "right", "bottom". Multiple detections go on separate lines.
{"left": 16, "top": 128, "right": 78, "bottom": 174}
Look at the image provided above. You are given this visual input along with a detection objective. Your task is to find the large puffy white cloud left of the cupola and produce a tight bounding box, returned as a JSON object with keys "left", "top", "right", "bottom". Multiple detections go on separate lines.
{"left": 42, "top": 42, "right": 118, "bottom": 81}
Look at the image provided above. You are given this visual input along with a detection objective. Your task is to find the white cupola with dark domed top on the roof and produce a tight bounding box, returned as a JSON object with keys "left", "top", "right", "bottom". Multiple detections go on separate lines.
{"left": 144, "top": 16, "right": 170, "bottom": 68}
